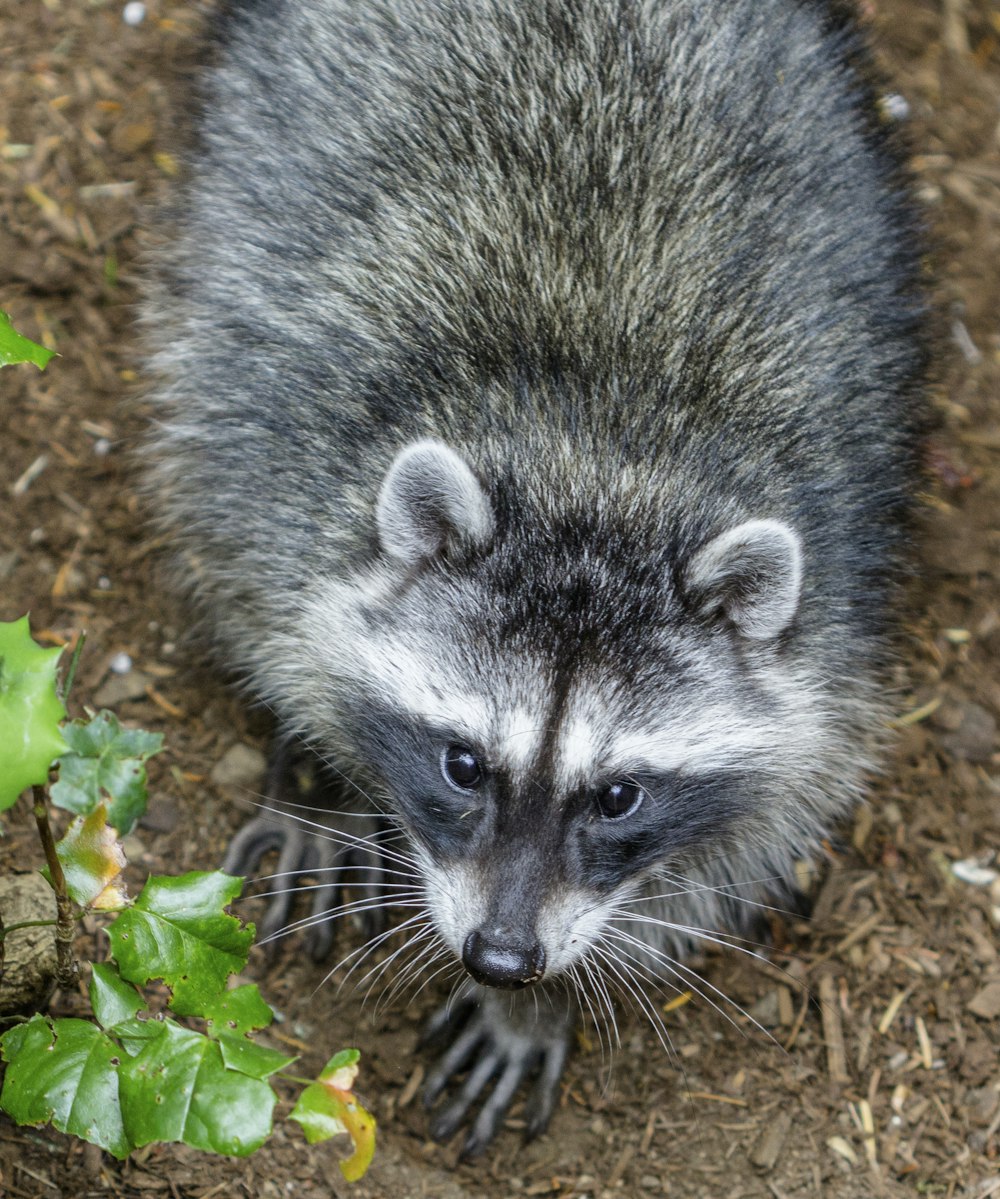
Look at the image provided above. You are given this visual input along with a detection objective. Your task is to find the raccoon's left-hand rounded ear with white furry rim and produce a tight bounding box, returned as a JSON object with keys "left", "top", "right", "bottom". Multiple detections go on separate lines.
{"left": 375, "top": 440, "right": 493, "bottom": 566}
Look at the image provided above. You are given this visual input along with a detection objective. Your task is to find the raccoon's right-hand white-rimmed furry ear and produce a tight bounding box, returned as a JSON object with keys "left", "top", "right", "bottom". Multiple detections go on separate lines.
{"left": 686, "top": 520, "right": 802, "bottom": 640}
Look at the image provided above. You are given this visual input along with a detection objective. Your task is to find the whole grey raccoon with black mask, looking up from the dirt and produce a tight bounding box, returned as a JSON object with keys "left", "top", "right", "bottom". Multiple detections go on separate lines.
{"left": 145, "top": 0, "right": 924, "bottom": 1153}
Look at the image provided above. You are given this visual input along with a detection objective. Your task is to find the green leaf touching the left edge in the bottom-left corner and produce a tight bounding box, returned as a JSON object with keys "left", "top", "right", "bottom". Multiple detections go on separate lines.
{"left": 0, "top": 1016, "right": 132, "bottom": 1157}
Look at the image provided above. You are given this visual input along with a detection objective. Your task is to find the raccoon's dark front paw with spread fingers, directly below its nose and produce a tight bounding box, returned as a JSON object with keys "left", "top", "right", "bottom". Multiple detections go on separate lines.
{"left": 423, "top": 987, "right": 573, "bottom": 1158}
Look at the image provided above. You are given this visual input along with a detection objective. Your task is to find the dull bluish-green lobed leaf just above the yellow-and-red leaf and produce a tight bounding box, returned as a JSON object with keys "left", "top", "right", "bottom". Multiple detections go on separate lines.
{"left": 50, "top": 711, "right": 163, "bottom": 836}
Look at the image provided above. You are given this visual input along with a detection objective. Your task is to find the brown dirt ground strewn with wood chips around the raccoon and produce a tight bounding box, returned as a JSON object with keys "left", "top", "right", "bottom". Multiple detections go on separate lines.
{"left": 0, "top": 0, "right": 1000, "bottom": 1199}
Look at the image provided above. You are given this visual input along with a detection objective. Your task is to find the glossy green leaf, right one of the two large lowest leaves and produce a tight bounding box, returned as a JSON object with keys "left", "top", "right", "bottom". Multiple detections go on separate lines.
{"left": 120, "top": 1020, "right": 277, "bottom": 1157}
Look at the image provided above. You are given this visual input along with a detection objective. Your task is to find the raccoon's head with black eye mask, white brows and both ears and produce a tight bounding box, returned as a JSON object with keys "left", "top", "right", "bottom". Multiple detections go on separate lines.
{"left": 296, "top": 441, "right": 824, "bottom": 988}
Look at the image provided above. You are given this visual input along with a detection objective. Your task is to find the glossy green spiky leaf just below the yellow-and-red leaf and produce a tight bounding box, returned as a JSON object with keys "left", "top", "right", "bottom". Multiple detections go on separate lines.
{"left": 108, "top": 870, "right": 253, "bottom": 1016}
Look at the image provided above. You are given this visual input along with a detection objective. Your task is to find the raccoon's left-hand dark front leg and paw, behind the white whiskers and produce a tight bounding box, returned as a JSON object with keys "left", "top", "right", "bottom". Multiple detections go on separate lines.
{"left": 222, "top": 737, "right": 385, "bottom": 962}
